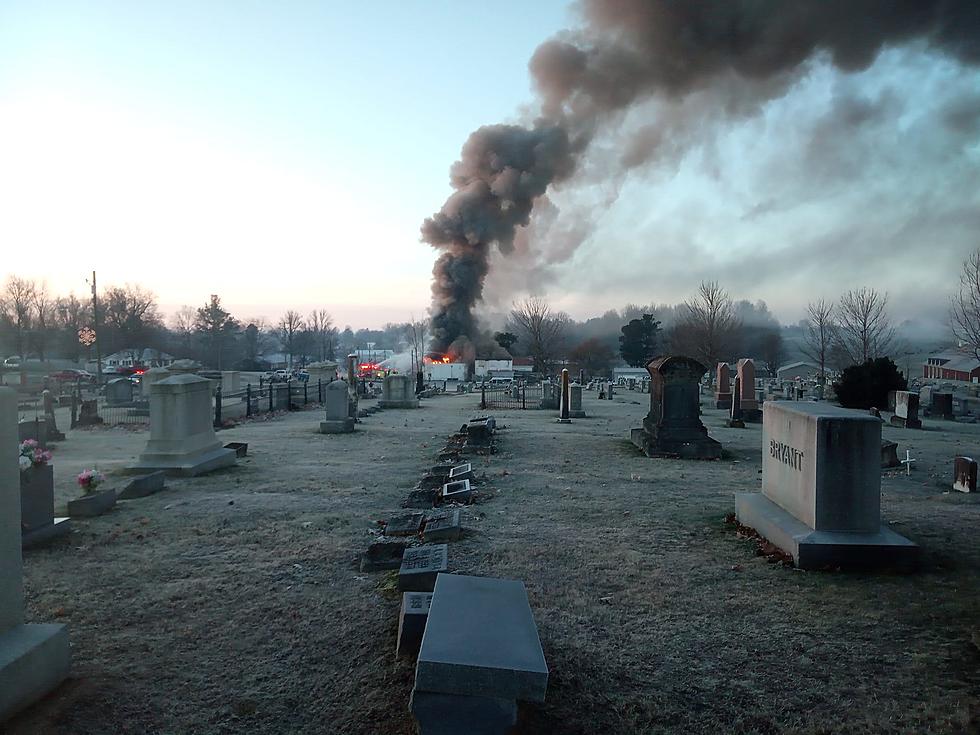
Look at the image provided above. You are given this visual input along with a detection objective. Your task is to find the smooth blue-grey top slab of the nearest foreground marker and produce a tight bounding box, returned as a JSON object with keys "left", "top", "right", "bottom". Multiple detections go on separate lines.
{"left": 415, "top": 576, "right": 548, "bottom": 702}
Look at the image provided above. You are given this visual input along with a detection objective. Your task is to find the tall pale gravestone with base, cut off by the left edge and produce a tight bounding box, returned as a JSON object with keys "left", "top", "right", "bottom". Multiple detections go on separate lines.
{"left": 0, "top": 387, "right": 71, "bottom": 722}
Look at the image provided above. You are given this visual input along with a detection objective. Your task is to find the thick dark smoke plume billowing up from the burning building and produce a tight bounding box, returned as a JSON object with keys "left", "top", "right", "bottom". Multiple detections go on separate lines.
{"left": 422, "top": 0, "right": 980, "bottom": 350}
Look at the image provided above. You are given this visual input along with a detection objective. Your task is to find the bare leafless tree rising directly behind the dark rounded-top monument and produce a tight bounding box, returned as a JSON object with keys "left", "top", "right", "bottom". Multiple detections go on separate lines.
{"left": 671, "top": 281, "right": 739, "bottom": 380}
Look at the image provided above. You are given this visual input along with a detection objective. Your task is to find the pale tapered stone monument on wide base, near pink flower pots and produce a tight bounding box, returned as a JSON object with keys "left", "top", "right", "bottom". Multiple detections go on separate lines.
{"left": 130, "top": 373, "right": 236, "bottom": 477}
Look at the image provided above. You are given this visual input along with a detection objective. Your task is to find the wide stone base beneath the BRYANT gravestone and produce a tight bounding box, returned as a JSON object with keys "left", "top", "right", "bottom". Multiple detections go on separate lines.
{"left": 735, "top": 493, "right": 919, "bottom": 571}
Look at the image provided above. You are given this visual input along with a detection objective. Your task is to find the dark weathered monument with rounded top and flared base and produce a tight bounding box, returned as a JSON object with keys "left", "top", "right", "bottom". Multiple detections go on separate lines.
{"left": 630, "top": 355, "right": 721, "bottom": 459}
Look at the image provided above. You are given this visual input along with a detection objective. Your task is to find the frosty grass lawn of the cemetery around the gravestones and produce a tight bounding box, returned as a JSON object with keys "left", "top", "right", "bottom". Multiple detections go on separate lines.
{"left": 6, "top": 392, "right": 980, "bottom": 735}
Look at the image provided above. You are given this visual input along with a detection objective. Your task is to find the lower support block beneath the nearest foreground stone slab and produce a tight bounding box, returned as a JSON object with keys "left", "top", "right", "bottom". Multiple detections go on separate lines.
{"left": 408, "top": 689, "right": 517, "bottom": 735}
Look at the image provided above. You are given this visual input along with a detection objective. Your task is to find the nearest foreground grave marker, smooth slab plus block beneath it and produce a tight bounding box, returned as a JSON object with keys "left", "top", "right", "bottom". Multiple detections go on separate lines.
{"left": 410, "top": 574, "right": 548, "bottom": 735}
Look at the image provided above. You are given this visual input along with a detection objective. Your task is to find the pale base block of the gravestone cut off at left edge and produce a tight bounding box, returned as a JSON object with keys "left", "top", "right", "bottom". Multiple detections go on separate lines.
{"left": 0, "top": 623, "right": 71, "bottom": 722}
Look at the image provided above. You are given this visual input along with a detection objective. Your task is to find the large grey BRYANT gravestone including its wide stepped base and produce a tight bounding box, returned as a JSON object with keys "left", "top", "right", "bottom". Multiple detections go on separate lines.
{"left": 735, "top": 402, "right": 919, "bottom": 569}
